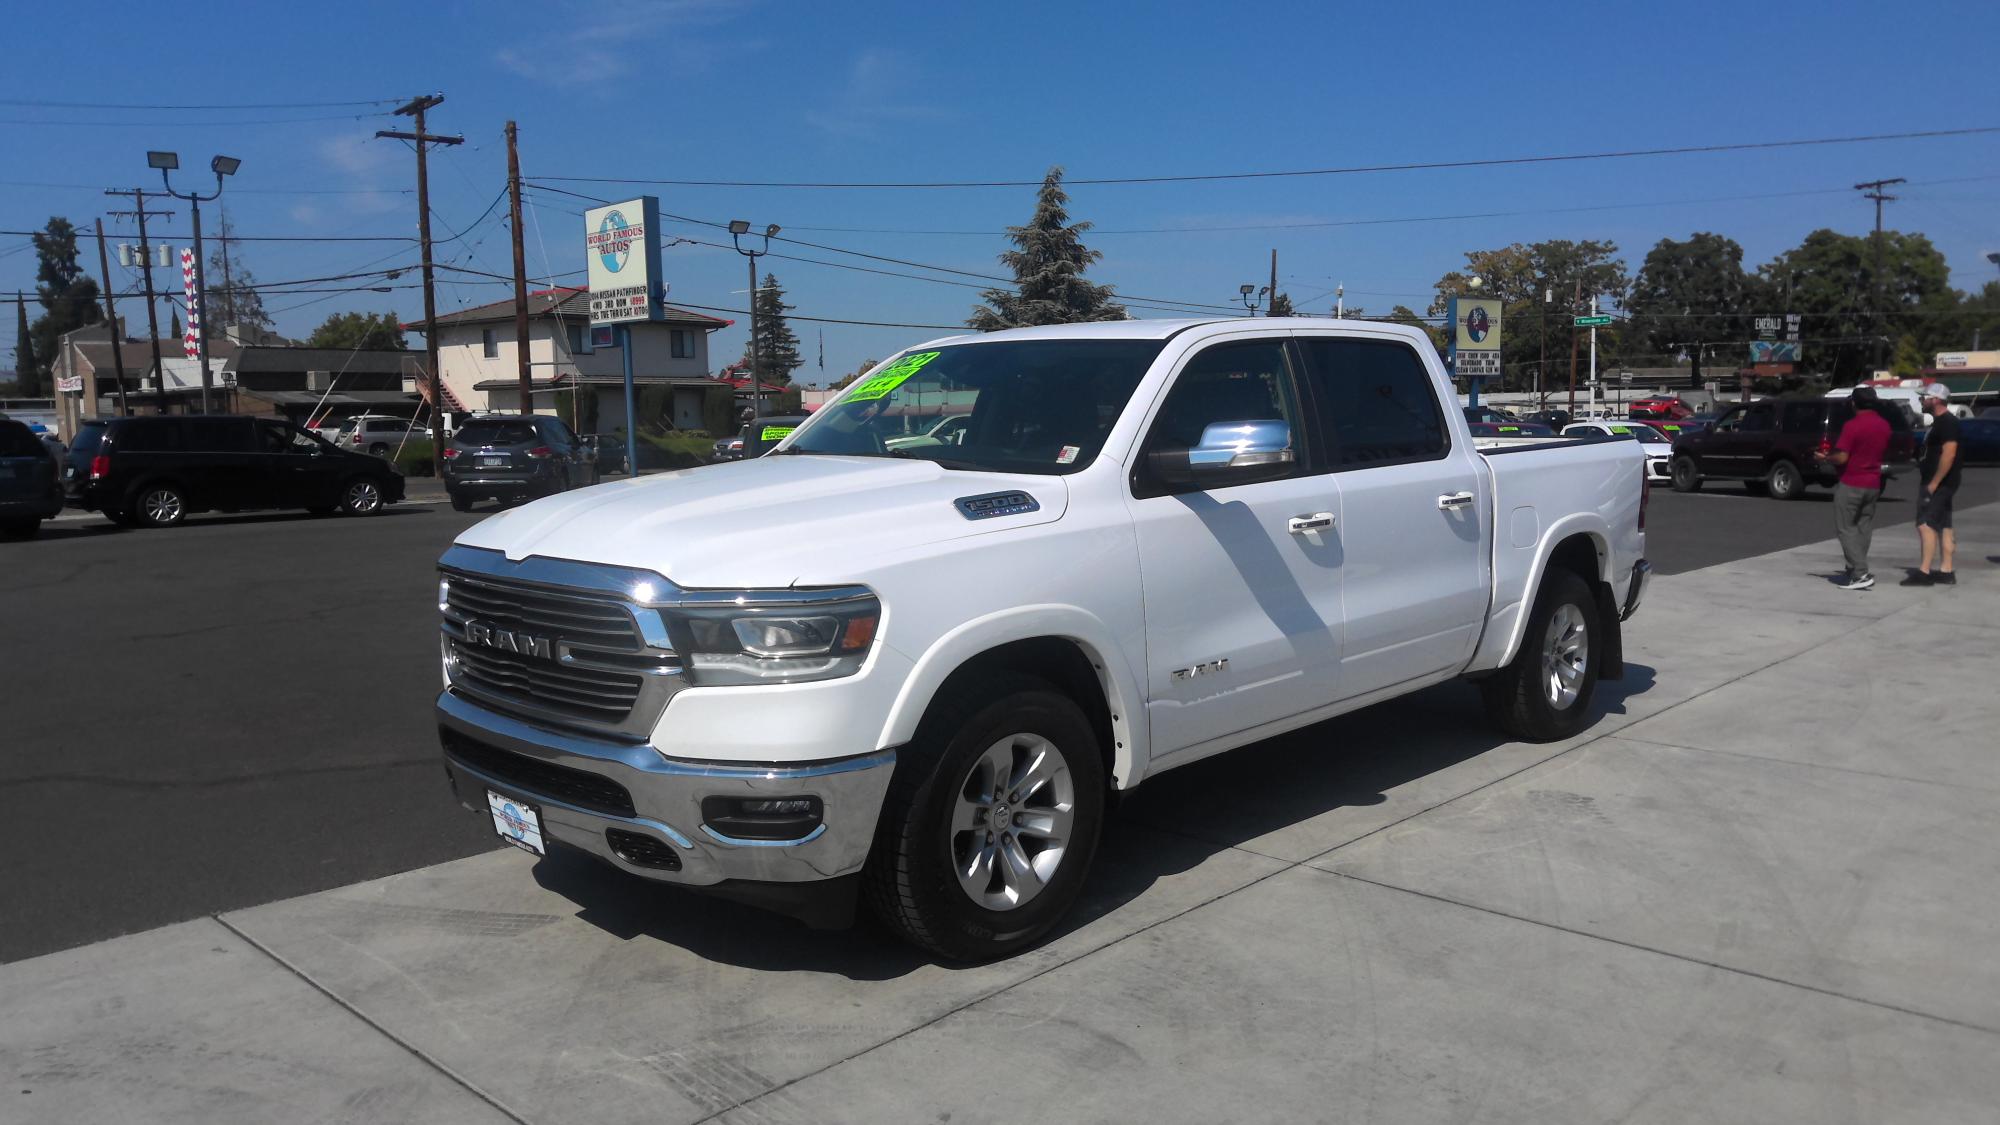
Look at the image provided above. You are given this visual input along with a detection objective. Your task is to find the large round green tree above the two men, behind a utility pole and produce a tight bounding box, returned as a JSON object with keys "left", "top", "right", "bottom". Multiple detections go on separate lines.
{"left": 1758, "top": 230, "right": 1962, "bottom": 386}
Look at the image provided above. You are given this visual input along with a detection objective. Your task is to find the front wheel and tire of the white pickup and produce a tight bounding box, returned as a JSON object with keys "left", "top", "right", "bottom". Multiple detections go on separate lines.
{"left": 862, "top": 675, "right": 1104, "bottom": 961}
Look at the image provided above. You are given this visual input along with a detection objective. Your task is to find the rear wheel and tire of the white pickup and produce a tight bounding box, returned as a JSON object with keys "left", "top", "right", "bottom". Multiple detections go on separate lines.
{"left": 1480, "top": 571, "right": 1602, "bottom": 743}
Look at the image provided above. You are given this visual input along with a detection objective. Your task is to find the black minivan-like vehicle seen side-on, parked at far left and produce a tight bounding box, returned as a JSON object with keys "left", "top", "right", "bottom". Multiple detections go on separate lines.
{"left": 62, "top": 414, "right": 402, "bottom": 526}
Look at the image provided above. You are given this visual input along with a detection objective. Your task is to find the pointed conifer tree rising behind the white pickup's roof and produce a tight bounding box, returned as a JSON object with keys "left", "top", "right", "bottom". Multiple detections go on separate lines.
{"left": 966, "top": 164, "right": 1126, "bottom": 332}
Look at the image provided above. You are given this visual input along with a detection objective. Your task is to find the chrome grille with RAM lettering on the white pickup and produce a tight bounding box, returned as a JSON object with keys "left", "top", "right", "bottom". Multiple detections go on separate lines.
{"left": 440, "top": 571, "right": 684, "bottom": 739}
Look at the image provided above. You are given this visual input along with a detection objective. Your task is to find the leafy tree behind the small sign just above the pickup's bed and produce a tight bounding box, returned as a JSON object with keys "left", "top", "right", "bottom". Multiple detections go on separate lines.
{"left": 1430, "top": 238, "right": 1630, "bottom": 384}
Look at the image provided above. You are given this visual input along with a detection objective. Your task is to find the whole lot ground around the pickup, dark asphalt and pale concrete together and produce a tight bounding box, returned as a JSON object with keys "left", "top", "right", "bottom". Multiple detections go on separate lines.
{"left": 0, "top": 470, "right": 2000, "bottom": 1121}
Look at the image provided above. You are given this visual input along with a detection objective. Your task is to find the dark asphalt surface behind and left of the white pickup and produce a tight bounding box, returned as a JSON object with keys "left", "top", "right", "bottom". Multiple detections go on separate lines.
{"left": 0, "top": 468, "right": 2000, "bottom": 961}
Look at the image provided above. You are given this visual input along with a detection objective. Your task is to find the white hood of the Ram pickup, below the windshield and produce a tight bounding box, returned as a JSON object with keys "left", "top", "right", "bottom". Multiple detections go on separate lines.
{"left": 458, "top": 456, "right": 1070, "bottom": 589}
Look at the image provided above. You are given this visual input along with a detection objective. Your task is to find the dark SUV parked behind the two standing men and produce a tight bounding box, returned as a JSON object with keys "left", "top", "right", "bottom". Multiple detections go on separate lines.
{"left": 1672, "top": 398, "right": 1916, "bottom": 500}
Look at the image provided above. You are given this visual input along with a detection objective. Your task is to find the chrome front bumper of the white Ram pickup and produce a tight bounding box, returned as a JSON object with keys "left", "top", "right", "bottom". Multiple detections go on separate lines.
{"left": 448, "top": 691, "right": 896, "bottom": 887}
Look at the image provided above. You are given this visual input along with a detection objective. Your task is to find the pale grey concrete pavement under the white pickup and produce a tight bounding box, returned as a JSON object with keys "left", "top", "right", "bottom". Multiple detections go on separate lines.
{"left": 0, "top": 506, "right": 2000, "bottom": 1125}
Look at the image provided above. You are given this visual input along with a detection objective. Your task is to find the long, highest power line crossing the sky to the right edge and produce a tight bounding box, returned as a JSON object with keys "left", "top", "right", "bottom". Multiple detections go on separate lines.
{"left": 536, "top": 126, "right": 2000, "bottom": 188}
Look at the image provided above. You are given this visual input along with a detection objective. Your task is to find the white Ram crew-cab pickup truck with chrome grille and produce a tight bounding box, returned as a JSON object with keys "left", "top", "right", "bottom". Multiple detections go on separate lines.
{"left": 436, "top": 318, "right": 1650, "bottom": 959}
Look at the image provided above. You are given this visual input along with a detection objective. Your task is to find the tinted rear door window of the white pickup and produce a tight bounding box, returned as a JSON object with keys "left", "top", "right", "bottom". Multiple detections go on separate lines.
{"left": 1298, "top": 336, "right": 1448, "bottom": 468}
